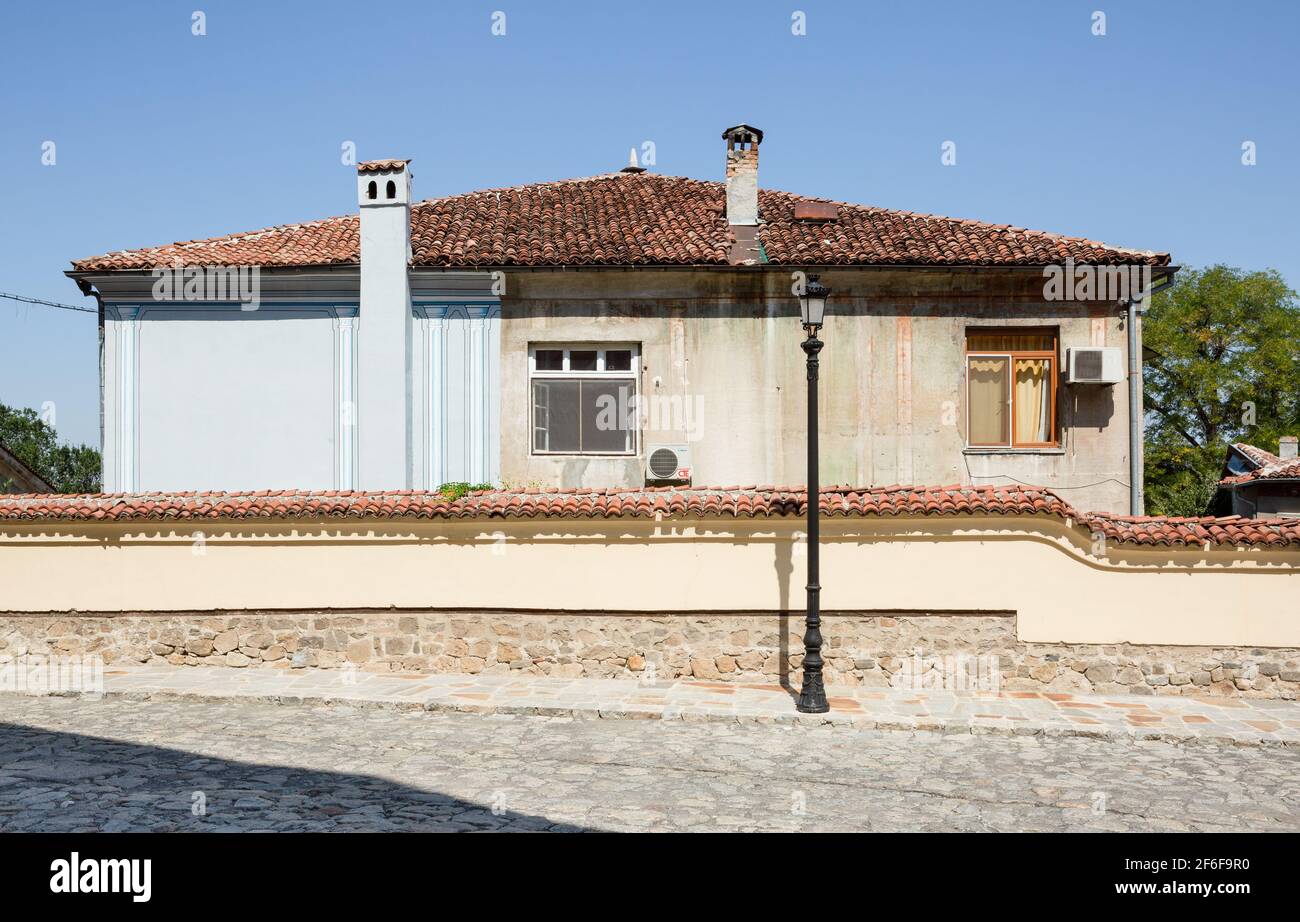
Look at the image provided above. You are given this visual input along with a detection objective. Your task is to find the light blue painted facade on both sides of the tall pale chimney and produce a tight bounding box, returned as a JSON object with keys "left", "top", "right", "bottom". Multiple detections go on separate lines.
{"left": 103, "top": 298, "right": 501, "bottom": 492}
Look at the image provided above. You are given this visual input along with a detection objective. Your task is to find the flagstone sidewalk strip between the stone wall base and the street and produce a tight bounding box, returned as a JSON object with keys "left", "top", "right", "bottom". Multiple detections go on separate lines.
{"left": 40, "top": 666, "right": 1300, "bottom": 748}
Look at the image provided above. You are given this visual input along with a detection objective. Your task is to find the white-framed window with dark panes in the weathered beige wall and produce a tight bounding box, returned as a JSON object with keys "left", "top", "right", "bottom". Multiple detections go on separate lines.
{"left": 528, "top": 343, "right": 638, "bottom": 455}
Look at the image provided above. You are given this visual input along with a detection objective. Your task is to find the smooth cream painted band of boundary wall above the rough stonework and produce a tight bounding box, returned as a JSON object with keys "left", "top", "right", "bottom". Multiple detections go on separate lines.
{"left": 0, "top": 518, "right": 1300, "bottom": 646}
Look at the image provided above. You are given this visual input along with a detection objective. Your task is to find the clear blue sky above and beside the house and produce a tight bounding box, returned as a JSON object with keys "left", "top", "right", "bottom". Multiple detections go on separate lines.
{"left": 0, "top": 0, "right": 1300, "bottom": 445}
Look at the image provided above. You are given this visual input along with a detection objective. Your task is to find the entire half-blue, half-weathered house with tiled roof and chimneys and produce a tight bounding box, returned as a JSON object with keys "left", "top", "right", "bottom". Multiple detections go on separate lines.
{"left": 68, "top": 125, "right": 1175, "bottom": 512}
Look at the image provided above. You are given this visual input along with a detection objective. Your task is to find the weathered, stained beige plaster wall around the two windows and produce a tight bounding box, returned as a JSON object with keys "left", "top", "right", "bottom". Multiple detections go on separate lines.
{"left": 502, "top": 270, "right": 1128, "bottom": 512}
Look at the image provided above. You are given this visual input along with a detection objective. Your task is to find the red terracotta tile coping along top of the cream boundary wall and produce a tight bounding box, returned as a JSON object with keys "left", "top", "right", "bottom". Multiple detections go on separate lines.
{"left": 0, "top": 485, "right": 1300, "bottom": 547}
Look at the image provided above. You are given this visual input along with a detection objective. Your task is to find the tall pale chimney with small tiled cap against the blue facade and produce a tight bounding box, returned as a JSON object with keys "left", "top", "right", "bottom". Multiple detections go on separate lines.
{"left": 356, "top": 160, "right": 411, "bottom": 490}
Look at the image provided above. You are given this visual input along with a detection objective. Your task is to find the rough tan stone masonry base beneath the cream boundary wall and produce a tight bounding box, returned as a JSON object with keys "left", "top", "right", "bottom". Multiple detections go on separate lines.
{"left": 0, "top": 611, "right": 1300, "bottom": 698}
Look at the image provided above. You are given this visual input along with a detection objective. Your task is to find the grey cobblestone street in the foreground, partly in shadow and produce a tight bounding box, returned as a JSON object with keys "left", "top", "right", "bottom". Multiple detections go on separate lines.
{"left": 0, "top": 696, "right": 1300, "bottom": 831}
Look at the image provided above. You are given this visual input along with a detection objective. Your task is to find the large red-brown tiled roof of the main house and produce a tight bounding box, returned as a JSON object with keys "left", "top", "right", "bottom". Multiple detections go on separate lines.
{"left": 73, "top": 172, "right": 1169, "bottom": 272}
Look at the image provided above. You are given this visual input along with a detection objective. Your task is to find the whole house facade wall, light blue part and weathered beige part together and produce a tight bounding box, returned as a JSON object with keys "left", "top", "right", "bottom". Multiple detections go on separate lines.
{"left": 94, "top": 269, "right": 1128, "bottom": 512}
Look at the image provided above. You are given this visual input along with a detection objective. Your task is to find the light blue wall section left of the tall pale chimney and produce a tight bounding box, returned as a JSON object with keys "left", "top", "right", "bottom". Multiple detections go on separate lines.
{"left": 104, "top": 303, "right": 351, "bottom": 492}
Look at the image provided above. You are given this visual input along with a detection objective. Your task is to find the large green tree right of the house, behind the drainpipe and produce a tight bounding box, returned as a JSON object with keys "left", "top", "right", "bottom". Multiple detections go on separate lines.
{"left": 1143, "top": 265, "right": 1300, "bottom": 515}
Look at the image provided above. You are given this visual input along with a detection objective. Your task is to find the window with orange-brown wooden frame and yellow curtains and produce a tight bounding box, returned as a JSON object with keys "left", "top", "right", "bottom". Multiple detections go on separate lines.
{"left": 966, "top": 329, "right": 1057, "bottom": 449}
